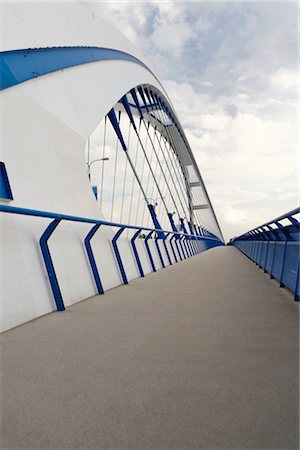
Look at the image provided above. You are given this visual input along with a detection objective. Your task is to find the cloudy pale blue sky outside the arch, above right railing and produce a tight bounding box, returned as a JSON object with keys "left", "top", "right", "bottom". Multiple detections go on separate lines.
{"left": 88, "top": 1, "right": 299, "bottom": 239}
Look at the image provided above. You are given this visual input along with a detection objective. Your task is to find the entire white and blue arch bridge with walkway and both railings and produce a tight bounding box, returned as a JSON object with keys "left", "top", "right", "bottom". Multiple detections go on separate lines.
{"left": 0, "top": 3, "right": 300, "bottom": 449}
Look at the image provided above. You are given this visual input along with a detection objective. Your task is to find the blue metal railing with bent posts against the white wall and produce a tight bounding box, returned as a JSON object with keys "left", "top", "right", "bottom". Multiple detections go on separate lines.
{"left": 0, "top": 205, "right": 223, "bottom": 311}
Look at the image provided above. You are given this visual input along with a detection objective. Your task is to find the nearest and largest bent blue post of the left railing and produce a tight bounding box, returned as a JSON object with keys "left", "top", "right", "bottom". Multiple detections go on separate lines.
{"left": 40, "top": 219, "right": 65, "bottom": 311}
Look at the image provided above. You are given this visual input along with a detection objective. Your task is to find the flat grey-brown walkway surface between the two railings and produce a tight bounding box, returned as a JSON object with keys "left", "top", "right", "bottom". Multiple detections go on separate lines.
{"left": 1, "top": 247, "right": 298, "bottom": 450}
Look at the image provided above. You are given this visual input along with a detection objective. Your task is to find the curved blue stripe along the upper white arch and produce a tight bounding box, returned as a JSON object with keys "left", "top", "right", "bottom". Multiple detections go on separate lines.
{"left": 0, "top": 47, "right": 154, "bottom": 91}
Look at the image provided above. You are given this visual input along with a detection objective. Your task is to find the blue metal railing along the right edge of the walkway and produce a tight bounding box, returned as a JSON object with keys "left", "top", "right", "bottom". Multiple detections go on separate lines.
{"left": 232, "top": 208, "right": 300, "bottom": 301}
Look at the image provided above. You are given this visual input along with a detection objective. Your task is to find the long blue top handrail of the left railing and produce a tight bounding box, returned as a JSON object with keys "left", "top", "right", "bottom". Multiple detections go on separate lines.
{"left": 0, "top": 204, "right": 220, "bottom": 241}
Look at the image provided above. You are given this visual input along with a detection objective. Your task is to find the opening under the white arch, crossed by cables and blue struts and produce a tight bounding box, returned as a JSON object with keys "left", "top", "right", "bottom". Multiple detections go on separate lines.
{"left": 87, "top": 85, "right": 221, "bottom": 238}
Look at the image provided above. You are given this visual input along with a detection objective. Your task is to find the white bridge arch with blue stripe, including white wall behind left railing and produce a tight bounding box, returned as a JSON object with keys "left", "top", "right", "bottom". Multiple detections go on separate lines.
{"left": 0, "top": 2, "right": 223, "bottom": 329}
